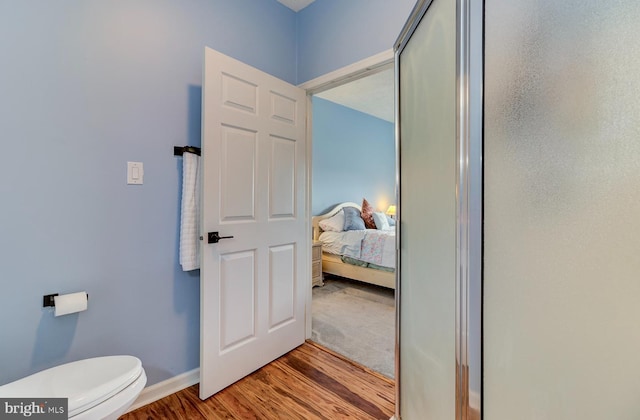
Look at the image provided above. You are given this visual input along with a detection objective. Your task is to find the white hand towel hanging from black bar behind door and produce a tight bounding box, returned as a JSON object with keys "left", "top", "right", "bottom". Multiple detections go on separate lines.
{"left": 180, "top": 152, "right": 200, "bottom": 271}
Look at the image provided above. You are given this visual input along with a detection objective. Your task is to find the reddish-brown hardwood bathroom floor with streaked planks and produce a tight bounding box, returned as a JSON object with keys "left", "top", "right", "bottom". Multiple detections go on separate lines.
{"left": 120, "top": 341, "right": 395, "bottom": 420}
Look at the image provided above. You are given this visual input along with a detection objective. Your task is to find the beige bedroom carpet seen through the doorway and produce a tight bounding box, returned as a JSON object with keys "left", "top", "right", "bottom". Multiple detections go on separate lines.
{"left": 311, "top": 277, "right": 395, "bottom": 378}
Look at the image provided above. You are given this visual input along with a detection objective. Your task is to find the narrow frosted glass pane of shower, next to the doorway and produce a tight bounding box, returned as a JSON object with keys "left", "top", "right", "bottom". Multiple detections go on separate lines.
{"left": 398, "top": 0, "right": 456, "bottom": 420}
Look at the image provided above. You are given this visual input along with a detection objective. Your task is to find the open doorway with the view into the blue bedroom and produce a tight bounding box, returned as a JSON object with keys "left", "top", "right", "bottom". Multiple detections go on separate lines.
{"left": 307, "top": 52, "right": 396, "bottom": 379}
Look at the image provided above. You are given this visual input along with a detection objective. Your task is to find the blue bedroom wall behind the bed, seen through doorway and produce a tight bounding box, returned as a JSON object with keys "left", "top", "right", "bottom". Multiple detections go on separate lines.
{"left": 311, "top": 97, "right": 395, "bottom": 215}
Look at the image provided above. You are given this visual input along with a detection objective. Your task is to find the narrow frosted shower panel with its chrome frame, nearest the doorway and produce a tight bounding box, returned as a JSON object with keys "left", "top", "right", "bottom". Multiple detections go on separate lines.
{"left": 396, "top": 0, "right": 482, "bottom": 419}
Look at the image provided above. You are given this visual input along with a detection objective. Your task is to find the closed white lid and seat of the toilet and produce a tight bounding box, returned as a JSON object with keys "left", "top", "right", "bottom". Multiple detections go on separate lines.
{"left": 0, "top": 356, "right": 142, "bottom": 416}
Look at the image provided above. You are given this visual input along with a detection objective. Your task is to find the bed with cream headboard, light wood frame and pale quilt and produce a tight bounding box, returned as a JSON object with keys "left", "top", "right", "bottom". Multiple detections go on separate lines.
{"left": 312, "top": 202, "right": 396, "bottom": 289}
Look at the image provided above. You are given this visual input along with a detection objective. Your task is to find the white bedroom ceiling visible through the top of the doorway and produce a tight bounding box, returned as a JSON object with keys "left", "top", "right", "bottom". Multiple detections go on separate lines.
{"left": 316, "top": 67, "right": 395, "bottom": 122}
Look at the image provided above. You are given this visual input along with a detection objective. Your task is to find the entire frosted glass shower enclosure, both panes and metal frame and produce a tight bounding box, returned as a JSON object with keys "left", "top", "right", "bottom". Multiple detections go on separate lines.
{"left": 396, "top": 0, "right": 640, "bottom": 420}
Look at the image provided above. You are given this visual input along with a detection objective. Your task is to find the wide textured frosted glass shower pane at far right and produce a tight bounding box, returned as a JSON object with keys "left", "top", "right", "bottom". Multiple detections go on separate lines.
{"left": 483, "top": 0, "right": 640, "bottom": 420}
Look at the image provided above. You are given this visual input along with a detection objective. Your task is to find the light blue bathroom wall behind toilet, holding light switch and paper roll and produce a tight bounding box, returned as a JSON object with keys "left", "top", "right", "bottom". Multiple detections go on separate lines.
{"left": 0, "top": 0, "right": 296, "bottom": 385}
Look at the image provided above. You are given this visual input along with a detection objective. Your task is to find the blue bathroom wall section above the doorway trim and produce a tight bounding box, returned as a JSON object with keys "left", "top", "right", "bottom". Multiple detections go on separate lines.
{"left": 297, "top": 0, "right": 416, "bottom": 83}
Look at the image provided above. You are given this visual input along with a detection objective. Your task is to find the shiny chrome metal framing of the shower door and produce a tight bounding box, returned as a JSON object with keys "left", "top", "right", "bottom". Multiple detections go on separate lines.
{"left": 394, "top": 0, "right": 484, "bottom": 420}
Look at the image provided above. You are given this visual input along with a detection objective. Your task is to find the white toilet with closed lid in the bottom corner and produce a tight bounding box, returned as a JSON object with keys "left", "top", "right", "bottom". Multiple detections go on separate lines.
{"left": 0, "top": 356, "right": 147, "bottom": 420}
